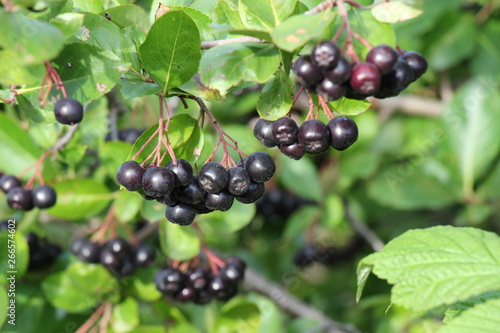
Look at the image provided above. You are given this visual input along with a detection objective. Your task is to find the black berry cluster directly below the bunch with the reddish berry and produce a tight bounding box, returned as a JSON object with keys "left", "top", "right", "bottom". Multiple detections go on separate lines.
{"left": 253, "top": 116, "right": 358, "bottom": 160}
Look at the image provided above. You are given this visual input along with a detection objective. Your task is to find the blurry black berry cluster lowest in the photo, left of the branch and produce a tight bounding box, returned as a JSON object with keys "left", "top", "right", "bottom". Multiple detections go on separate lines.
{"left": 154, "top": 257, "right": 246, "bottom": 304}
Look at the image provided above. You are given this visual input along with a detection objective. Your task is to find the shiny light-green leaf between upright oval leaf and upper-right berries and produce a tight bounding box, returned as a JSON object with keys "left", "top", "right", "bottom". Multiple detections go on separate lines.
{"left": 200, "top": 43, "right": 280, "bottom": 96}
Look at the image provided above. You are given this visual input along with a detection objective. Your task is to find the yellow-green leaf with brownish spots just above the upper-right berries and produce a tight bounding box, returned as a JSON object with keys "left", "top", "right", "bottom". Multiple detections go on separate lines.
{"left": 271, "top": 10, "right": 336, "bottom": 52}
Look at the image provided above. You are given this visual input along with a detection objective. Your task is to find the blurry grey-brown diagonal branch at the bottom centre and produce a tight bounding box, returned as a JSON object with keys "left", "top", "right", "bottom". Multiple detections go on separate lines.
{"left": 245, "top": 268, "right": 359, "bottom": 333}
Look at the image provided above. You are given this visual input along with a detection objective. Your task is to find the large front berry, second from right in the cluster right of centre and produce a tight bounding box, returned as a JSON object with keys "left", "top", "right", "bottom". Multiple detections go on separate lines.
{"left": 297, "top": 119, "right": 330, "bottom": 154}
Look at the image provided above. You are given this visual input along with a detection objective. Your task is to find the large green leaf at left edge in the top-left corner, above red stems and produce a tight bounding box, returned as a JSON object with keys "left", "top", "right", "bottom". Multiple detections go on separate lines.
{"left": 0, "top": 8, "right": 64, "bottom": 85}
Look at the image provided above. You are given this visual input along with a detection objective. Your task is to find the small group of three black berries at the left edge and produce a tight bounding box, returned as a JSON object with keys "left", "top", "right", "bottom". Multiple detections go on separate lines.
{"left": 0, "top": 175, "right": 57, "bottom": 211}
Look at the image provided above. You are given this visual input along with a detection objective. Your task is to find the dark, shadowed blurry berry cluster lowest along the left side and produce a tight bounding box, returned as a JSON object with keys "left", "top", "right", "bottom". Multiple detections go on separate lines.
{"left": 24, "top": 232, "right": 61, "bottom": 270}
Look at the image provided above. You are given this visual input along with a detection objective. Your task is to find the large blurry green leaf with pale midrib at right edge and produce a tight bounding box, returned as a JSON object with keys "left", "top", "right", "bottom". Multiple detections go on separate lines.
{"left": 442, "top": 79, "right": 500, "bottom": 196}
